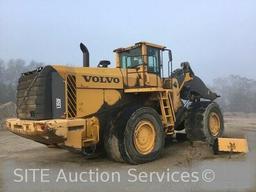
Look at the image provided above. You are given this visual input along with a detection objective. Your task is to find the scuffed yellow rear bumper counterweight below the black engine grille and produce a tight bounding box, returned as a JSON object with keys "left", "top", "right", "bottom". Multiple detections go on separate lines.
{"left": 6, "top": 117, "right": 100, "bottom": 149}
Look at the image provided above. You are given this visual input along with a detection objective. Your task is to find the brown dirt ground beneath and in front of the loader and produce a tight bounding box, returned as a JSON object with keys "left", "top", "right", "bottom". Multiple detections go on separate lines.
{"left": 0, "top": 113, "right": 256, "bottom": 192}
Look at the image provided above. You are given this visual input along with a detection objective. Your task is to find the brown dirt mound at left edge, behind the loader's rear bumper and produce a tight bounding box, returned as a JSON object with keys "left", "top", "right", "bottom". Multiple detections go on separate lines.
{"left": 0, "top": 102, "right": 16, "bottom": 129}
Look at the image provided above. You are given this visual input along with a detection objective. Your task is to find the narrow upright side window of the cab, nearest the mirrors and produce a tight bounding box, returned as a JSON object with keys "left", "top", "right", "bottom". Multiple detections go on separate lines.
{"left": 148, "top": 47, "right": 160, "bottom": 74}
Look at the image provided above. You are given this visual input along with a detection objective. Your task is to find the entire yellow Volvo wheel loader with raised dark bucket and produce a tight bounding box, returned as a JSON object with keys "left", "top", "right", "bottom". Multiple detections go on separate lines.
{"left": 6, "top": 42, "right": 247, "bottom": 164}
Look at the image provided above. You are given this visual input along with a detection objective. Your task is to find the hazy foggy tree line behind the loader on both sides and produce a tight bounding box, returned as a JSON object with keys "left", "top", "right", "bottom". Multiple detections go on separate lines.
{"left": 0, "top": 59, "right": 256, "bottom": 113}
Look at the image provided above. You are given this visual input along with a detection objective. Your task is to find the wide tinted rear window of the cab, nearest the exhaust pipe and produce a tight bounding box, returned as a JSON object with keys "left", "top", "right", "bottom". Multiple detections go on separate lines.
{"left": 120, "top": 47, "right": 143, "bottom": 68}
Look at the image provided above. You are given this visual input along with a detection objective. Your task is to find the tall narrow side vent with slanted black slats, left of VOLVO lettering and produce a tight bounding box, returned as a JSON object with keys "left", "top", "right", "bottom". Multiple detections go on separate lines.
{"left": 67, "top": 75, "right": 76, "bottom": 118}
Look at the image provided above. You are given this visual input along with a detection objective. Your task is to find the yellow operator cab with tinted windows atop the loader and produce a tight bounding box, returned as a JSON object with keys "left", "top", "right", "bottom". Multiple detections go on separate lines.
{"left": 114, "top": 42, "right": 171, "bottom": 88}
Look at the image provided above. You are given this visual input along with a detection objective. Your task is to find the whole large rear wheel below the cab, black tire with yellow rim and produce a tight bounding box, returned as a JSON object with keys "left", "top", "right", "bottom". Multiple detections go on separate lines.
{"left": 105, "top": 106, "right": 165, "bottom": 164}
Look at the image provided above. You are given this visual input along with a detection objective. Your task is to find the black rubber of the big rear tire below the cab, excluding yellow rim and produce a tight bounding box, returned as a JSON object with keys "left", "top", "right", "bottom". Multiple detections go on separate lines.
{"left": 105, "top": 107, "right": 165, "bottom": 164}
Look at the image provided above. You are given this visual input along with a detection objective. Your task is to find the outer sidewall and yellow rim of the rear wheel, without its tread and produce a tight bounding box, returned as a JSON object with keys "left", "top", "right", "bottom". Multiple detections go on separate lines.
{"left": 121, "top": 107, "right": 165, "bottom": 164}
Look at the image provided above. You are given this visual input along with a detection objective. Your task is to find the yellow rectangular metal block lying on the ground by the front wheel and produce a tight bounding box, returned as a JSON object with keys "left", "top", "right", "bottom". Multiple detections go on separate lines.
{"left": 213, "top": 138, "right": 249, "bottom": 154}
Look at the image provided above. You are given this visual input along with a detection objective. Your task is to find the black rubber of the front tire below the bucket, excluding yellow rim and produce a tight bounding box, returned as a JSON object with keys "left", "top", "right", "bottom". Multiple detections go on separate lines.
{"left": 185, "top": 101, "right": 224, "bottom": 145}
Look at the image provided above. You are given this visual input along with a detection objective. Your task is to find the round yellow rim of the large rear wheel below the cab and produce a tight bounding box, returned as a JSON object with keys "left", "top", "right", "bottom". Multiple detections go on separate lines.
{"left": 133, "top": 120, "right": 156, "bottom": 155}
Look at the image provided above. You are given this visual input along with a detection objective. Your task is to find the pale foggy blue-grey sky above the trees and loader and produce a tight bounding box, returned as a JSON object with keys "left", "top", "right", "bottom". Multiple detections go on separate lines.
{"left": 0, "top": 0, "right": 256, "bottom": 82}
